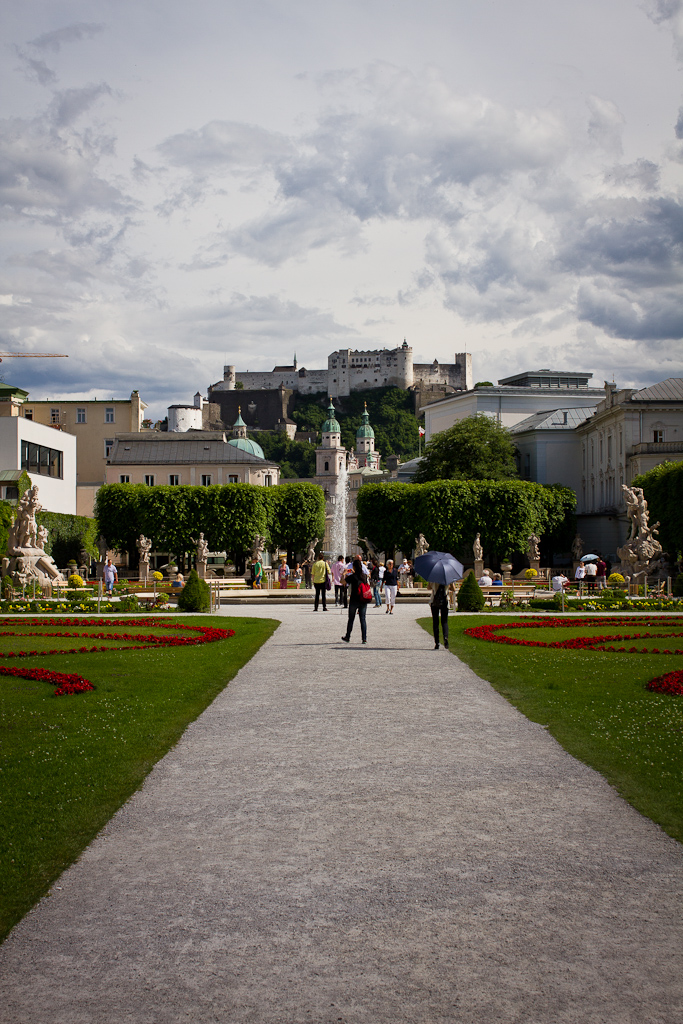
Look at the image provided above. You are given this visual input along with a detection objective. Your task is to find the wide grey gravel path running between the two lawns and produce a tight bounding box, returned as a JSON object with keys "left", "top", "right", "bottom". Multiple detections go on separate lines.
{"left": 0, "top": 606, "right": 683, "bottom": 1024}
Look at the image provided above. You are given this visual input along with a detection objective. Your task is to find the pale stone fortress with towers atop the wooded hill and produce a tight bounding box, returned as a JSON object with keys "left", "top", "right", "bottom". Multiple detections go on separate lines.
{"left": 210, "top": 341, "right": 472, "bottom": 398}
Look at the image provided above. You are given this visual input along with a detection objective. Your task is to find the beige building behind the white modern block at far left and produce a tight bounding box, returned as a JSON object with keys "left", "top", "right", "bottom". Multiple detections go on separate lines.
{"left": 18, "top": 391, "right": 147, "bottom": 516}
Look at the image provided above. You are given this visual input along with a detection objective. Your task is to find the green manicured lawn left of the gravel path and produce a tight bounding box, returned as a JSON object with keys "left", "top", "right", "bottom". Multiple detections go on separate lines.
{"left": 0, "top": 615, "right": 279, "bottom": 940}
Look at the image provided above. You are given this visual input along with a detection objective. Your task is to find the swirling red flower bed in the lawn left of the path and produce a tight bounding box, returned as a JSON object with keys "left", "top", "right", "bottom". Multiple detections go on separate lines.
{"left": 0, "top": 618, "right": 234, "bottom": 696}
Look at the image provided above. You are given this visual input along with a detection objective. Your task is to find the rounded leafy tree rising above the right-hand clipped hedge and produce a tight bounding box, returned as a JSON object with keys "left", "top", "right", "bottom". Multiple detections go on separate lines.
{"left": 415, "top": 416, "right": 517, "bottom": 483}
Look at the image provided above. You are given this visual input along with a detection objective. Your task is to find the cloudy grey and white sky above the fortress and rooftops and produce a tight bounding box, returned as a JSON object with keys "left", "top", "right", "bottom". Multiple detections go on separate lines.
{"left": 0, "top": 0, "right": 683, "bottom": 418}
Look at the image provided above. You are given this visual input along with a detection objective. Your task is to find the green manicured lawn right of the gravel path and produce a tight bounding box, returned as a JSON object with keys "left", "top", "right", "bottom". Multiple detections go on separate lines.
{"left": 420, "top": 614, "right": 683, "bottom": 842}
